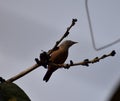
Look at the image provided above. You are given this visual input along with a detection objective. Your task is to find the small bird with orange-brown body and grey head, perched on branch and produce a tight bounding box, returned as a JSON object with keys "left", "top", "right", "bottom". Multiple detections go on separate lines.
{"left": 43, "top": 40, "right": 78, "bottom": 82}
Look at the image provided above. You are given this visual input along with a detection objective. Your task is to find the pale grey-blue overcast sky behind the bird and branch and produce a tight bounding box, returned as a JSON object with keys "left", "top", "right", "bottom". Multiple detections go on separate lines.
{"left": 0, "top": 0, "right": 120, "bottom": 101}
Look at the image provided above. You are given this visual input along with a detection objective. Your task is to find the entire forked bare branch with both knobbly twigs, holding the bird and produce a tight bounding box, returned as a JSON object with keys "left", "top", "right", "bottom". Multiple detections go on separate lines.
{"left": 6, "top": 19, "right": 116, "bottom": 82}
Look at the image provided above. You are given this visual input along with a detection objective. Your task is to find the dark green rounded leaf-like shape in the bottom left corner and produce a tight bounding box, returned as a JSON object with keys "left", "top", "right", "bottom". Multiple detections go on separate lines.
{"left": 0, "top": 81, "right": 31, "bottom": 101}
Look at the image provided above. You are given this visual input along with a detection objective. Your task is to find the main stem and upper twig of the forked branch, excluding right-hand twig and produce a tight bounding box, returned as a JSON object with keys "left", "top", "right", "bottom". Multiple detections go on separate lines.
{"left": 6, "top": 19, "right": 77, "bottom": 82}
